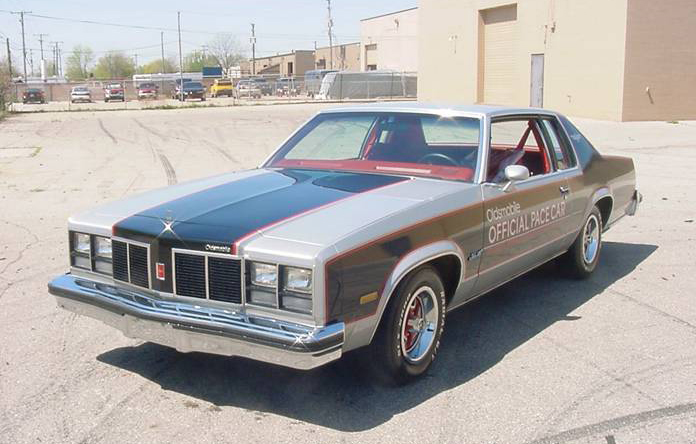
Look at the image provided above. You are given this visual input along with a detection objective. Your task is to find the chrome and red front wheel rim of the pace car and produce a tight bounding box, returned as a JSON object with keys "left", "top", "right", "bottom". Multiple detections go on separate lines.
{"left": 401, "top": 287, "right": 440, "bottom": 363}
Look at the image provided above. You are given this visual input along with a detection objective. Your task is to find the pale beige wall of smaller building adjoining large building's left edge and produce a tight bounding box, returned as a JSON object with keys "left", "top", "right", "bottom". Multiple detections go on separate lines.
{"left": 360, "top": 8, "right": 419, "bottom": 71}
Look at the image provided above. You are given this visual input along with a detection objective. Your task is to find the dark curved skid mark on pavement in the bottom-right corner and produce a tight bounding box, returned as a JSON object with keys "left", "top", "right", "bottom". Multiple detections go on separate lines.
{"left": 526, "top": 402, "right": 696, "bottom": 444}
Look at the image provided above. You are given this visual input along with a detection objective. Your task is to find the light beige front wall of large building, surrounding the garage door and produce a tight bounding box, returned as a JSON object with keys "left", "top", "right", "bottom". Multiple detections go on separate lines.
{"left": 418, "top": 0, "right": 627, "bottom": 120}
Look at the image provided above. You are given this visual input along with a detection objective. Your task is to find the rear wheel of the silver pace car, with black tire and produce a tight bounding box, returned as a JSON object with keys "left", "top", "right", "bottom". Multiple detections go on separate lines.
{"left": 559, "top": 207, "right": 603, "bottom": 279}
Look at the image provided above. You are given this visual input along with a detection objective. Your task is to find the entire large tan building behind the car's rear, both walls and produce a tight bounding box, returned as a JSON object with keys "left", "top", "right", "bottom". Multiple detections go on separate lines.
{"left": 418, "top": 0, "right": 696, "bottom": 121}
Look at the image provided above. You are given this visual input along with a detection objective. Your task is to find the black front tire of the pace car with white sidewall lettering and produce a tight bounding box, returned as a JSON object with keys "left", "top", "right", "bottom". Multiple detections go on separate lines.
{"left": 367, "top": 266, "right": 445, "bottom": 385}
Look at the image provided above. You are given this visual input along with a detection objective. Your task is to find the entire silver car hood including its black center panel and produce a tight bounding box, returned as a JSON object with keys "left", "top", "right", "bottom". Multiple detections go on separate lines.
{"left": 70, "top": 169, "right": 474, "bottom": 251}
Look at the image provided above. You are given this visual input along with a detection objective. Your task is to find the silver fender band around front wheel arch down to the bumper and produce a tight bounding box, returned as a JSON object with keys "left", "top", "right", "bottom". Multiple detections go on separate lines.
{"left": 344, "top": 240, "right": 465, "bottom": 351}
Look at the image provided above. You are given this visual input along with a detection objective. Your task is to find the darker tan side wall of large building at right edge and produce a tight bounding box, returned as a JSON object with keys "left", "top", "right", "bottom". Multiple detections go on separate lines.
{"left": 623, "top": 0, "right": 696, "bottom": 120}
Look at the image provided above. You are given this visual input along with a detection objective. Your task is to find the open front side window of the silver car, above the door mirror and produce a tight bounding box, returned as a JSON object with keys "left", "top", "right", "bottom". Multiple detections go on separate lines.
{"left": 487, "top": 118, "right": 551, "bottom": 183}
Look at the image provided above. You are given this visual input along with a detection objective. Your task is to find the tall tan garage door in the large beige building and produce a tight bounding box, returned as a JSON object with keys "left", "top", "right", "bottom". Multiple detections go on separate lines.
{"left": 481, "top": 5, "right": 517, "bottom": 105}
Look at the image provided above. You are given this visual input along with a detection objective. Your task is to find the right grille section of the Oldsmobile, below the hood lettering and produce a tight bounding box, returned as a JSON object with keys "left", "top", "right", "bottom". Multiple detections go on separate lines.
{"left": 173, "top": 250, "right": 242, "bottom": 304}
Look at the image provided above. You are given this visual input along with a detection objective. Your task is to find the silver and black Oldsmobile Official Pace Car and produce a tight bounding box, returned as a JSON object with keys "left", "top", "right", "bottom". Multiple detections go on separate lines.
{"left": 49, "top": 103, "right": 641, "bottom": 383}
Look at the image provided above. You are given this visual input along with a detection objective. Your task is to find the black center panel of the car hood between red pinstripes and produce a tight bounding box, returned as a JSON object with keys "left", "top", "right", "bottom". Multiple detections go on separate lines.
{"left": 113, "top": 169, "right": 406, "bottom": 250}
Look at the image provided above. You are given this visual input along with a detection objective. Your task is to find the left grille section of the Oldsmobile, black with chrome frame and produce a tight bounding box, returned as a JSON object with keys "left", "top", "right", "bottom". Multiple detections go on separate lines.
{"left": 111, "top": 239, "right": 150, "bottom": 288}
